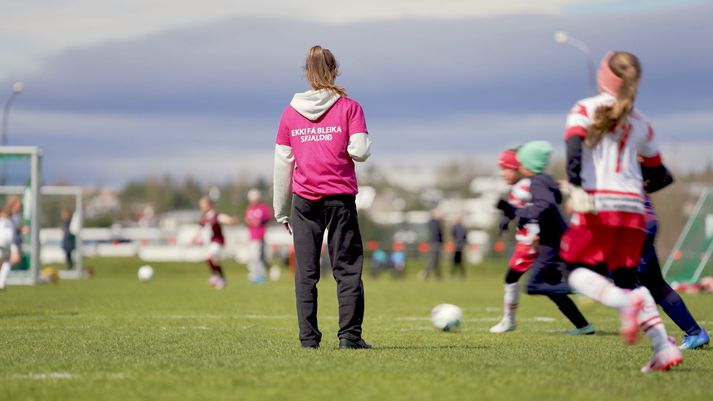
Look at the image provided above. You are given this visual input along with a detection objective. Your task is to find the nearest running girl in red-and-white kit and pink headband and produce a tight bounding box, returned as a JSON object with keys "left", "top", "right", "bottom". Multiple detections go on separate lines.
{"left": 561, "top": 52, "right": 683, "bottom": 372}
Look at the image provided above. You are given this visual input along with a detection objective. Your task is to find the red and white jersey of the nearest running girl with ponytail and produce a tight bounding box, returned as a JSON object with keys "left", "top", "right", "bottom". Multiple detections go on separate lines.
{"left": 565, "top": 94, "right": 661, "bottom": 228}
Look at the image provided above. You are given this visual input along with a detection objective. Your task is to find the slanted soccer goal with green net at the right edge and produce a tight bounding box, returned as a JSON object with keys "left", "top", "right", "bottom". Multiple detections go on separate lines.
{"left": 663, "top": 189, "right": 713, "bottom": 283}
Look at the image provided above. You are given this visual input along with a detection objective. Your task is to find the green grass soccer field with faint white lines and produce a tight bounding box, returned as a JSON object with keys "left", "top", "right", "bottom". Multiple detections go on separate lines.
{"left": 0, "top": 259, "right": 713, "bottom": 401}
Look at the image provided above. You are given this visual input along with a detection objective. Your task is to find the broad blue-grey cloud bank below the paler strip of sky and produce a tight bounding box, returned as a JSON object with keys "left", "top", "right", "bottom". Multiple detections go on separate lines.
{"left": 5, "top": 5, "right": 713, "bottom": 184}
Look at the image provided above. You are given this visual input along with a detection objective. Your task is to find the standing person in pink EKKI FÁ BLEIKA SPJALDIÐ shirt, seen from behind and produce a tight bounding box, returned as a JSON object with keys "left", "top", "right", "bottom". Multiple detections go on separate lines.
{"left": 273, "top": 46, "right": 371, "bottom": 349}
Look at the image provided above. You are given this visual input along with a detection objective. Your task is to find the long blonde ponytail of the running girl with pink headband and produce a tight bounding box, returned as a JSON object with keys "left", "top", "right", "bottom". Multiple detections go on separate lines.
{"left": 585, "top": 52, "right": 641, "bottom": 148}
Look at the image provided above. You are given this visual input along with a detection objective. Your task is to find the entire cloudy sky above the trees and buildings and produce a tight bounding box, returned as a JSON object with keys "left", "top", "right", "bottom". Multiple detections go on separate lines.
{"left": 0, "top": 0, "right": 713, "bottom": 185}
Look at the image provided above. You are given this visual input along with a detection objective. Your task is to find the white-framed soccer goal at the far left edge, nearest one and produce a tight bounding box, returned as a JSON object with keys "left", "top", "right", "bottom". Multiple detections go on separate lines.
{"left": 0, "top": 146, "right": 42, "bottom": 285}
